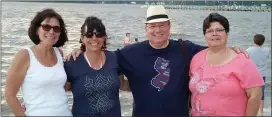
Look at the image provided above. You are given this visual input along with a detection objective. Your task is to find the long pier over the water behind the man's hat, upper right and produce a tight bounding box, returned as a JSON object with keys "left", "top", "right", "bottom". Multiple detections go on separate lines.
{"left": 141, "top": 1, "right": 272, "bottom": 12}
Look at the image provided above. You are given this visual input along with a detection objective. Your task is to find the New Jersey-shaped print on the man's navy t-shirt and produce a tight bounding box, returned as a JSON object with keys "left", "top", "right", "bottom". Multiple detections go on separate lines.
{"left": 151, "top": 57, "right": 170, "bottom": 91}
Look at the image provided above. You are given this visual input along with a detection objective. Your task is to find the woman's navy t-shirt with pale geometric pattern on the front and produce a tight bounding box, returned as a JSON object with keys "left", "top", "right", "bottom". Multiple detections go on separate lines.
{"left": 64, "top": 51, "right": 121, "bottom": 117}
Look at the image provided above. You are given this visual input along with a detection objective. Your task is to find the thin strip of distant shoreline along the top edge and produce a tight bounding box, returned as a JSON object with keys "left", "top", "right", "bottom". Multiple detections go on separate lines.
{"left": 2, "top": 0, "right": 272, "bottom": 7}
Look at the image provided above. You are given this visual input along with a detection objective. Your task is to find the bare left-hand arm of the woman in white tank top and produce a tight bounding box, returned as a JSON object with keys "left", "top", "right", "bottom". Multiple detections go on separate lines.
{"left": 5, "top": 49, "right": 30, "bottom": 116}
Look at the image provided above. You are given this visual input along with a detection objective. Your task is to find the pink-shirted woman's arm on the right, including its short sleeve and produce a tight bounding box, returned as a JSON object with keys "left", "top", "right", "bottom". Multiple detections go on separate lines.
{"left": 236, "top": 54, "right": 264, "bottom": 116}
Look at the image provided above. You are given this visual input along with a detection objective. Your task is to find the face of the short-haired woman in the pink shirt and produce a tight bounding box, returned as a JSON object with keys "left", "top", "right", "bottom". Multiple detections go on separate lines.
{"left": 205, "top": 22, "right": 228, "bottom": 47}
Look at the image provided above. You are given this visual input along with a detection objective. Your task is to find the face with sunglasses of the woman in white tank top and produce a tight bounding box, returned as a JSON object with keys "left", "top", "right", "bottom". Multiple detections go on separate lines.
{"left": 37, "top": 18, "right": 61, "bottom": 46}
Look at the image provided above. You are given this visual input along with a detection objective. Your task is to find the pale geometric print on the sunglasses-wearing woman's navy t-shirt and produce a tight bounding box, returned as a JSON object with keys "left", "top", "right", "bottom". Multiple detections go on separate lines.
{"left": 84, "top": 74, "right": 114, "bottom": 116}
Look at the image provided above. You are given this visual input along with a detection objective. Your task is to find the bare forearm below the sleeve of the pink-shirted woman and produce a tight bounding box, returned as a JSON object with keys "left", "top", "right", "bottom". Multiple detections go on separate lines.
{"left": 246, "top": 87, "right": 262, "bottom": 116}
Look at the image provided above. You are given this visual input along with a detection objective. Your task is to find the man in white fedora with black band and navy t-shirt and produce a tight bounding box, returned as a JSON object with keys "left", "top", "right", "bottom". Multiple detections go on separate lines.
{"left": 67, "top": 5, "right": 246, "bottom": 117}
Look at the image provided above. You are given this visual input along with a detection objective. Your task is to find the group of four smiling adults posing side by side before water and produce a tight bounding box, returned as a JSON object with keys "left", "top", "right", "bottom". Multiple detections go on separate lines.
{"left": 5, "top": 5, "right": 264, "bottom": 116}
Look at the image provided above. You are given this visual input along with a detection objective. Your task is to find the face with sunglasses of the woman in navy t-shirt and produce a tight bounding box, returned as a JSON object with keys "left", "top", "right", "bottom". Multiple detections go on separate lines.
{"left": 82, "top": 30, "right": 106, "bottom": 52}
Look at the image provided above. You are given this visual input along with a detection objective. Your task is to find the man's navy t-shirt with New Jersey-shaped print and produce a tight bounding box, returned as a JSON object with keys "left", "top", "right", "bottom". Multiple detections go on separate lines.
{"left": 116, "top": 40, "right": 206, "bottom": 116}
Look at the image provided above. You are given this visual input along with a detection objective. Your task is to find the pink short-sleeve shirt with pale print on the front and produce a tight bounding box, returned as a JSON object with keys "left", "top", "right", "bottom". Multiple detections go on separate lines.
{"left": 189, "top": 49, "right": 264, "bottom": 116}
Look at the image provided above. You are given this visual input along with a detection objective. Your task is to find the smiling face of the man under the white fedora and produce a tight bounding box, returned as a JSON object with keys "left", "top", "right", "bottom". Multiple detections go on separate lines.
{"left": 146, "top": 21, "right": 170, "bottom": 45}
